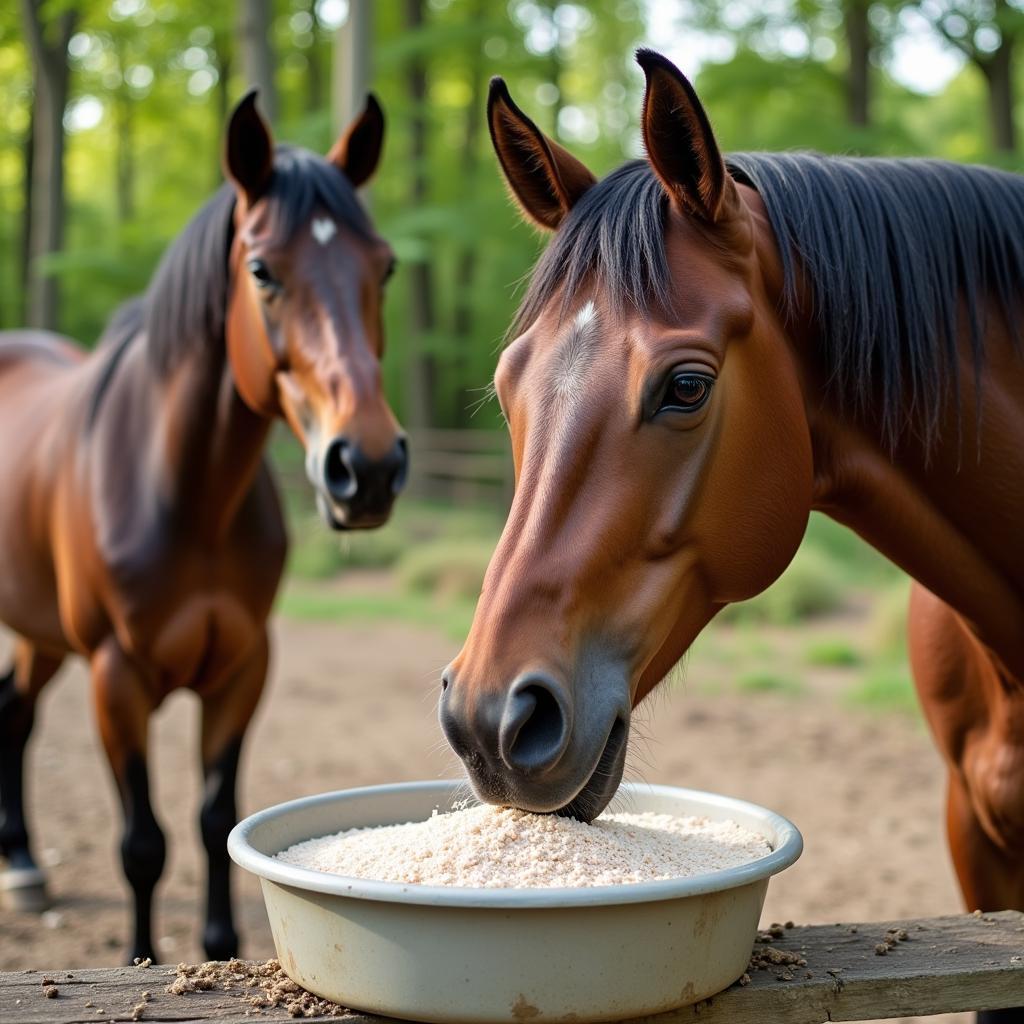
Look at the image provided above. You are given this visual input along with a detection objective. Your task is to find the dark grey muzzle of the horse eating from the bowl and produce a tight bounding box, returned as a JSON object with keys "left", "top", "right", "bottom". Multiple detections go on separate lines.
{"left": 439, "top": 668, "right": 630, "bottom": 821}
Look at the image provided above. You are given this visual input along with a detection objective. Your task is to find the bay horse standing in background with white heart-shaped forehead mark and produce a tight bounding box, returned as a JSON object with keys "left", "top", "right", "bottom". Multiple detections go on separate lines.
{"left": 0, "top": 92, "right": 407, "bottom": 959}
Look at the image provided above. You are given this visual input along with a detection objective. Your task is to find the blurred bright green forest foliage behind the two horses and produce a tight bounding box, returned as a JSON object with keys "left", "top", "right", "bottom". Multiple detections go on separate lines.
{"left": 6, "top": 0, "right": 1019, "bottom": 376}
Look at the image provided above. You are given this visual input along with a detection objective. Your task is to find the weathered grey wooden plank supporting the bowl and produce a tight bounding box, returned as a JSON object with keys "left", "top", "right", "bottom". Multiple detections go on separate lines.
{"left": 0, "top": 911, "right": 1024, "bottom": 1024}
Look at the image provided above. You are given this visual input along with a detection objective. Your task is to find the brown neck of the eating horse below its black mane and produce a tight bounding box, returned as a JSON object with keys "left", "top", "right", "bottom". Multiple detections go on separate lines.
{"left": 800, "top": 307, "right": 1024, "bottom": 679}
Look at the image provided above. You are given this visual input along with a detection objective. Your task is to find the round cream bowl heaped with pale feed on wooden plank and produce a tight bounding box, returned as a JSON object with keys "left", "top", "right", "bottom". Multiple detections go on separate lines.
{"left": 228, "top": 782, "right": 803, "bottom": 1024}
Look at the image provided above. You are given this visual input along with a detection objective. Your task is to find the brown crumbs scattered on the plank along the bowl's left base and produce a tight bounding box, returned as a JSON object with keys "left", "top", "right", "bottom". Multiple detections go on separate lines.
{"left": 167, "top": 959, "right": 349, "bottom": 1017}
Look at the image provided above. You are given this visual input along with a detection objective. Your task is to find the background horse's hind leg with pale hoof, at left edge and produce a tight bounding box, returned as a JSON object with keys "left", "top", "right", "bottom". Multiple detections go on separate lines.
{"left": 0, "top": 639, "right": 63, "bottom": 912}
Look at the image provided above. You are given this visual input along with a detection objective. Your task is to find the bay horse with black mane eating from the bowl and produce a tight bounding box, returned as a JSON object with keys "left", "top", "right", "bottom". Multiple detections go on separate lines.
{"left": 439, "top": 50, "right": 1024, "bottom": 1021}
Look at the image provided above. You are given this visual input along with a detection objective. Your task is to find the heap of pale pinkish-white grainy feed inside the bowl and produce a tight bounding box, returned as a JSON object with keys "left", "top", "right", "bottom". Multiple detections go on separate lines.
{"left": 278, "top": 805, "right": 771, "bottom": 889}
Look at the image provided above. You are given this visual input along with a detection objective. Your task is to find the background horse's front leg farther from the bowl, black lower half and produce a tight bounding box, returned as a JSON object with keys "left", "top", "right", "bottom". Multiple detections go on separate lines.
{"left": 92, "top": 640, "right": 167, "bottom": 959}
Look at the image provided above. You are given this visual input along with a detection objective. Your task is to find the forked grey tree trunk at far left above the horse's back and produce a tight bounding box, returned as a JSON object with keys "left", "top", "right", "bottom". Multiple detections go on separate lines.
{"left": 22, "top": 0, "right": 78, "bottom": 329}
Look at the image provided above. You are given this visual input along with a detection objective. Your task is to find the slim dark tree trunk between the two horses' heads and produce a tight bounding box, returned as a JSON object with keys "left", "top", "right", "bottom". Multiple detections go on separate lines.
{"left": 406, "top": 0, "right": 436, "bottom": 430}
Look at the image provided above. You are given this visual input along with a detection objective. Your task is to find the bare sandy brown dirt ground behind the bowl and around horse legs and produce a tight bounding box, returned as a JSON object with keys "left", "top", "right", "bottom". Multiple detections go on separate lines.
{"left": 0, "top": 621, "right": 968, "bottom": 1024}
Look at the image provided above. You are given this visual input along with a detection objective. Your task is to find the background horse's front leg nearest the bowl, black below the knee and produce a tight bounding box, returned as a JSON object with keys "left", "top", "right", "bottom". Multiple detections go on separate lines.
{"left": 200, "top": 635, "right": 267, "bottom": 959}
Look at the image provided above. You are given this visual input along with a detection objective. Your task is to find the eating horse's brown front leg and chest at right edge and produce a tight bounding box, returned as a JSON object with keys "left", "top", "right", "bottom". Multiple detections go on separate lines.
{"left": 910, "top": 587, "right": 1024, "bottom": 1024}
